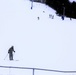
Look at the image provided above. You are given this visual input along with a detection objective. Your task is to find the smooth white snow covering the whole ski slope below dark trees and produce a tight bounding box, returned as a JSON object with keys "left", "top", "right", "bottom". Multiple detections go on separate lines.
{"left": 0, "top": 0, "right": 76, "bottom": 75}
